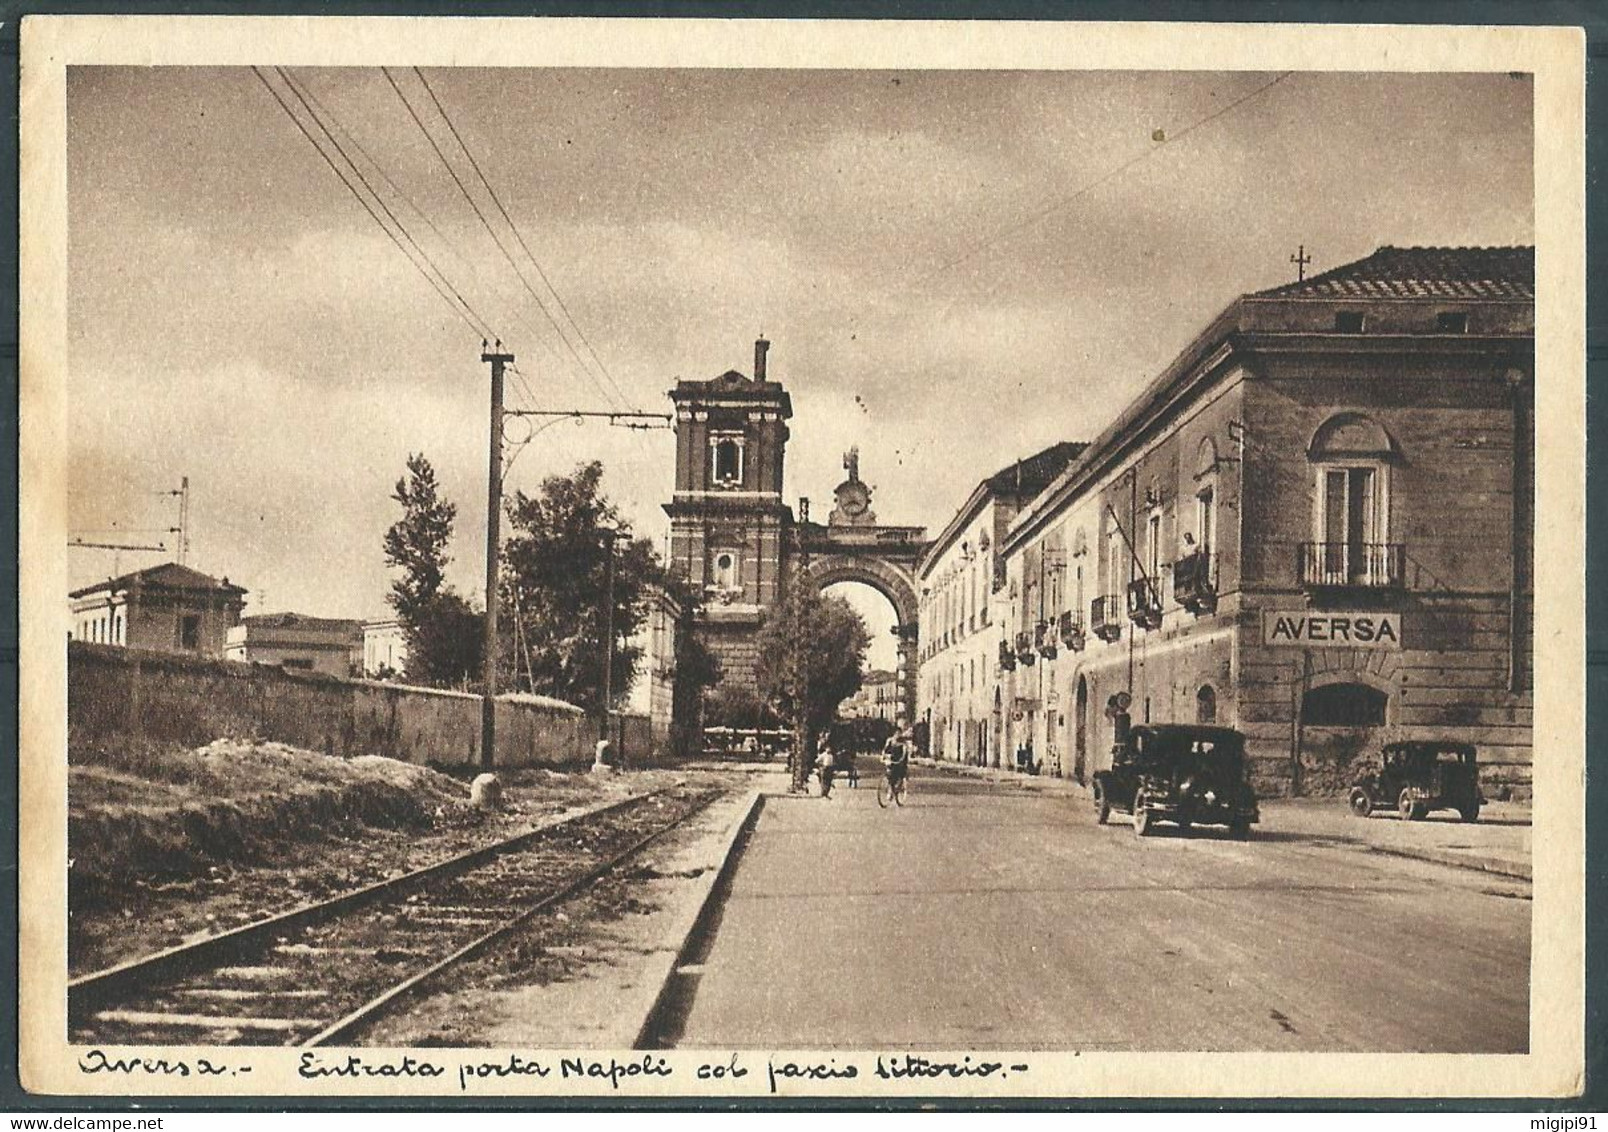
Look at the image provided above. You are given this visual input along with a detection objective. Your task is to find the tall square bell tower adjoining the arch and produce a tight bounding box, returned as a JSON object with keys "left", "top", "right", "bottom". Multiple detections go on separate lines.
{"left": 664, "top": 338, "right": 793, "bottom": 688}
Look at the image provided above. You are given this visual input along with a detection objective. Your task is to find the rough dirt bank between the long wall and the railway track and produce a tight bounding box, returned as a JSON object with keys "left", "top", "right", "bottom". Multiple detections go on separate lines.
{"left": 68, "top": 743, "right": 752, "bottom": 976}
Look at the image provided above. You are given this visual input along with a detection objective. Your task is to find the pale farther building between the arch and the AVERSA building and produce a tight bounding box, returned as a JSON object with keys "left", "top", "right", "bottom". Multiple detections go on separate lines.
{"left": 917, "top": 441, "right": 1084, "bottom": 767}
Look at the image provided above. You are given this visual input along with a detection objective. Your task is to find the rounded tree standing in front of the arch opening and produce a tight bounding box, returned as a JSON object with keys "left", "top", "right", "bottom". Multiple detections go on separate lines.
{"left": 757, "top": 577, "right": 872, "bottom": 788}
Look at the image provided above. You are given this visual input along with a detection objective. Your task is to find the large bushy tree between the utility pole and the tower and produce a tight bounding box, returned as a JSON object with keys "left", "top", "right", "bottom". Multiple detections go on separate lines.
{"left": 500, "top": 460, "right": 662, "bottom": 711}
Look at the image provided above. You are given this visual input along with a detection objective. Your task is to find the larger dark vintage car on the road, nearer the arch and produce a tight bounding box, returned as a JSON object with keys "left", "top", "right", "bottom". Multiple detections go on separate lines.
{"left": 1093, "top": 724, "right": 1261, "bottom": 838}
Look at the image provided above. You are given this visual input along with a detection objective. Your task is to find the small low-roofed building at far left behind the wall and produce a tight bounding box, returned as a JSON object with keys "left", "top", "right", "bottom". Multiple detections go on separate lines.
{"left": 68, "top": 563, "right": 246, "bottom": 656}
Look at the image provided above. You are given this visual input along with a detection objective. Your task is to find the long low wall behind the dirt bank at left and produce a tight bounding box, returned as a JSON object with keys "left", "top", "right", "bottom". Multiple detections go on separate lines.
{"left": 68, "top": 642, "right": 627, "bottom": 769}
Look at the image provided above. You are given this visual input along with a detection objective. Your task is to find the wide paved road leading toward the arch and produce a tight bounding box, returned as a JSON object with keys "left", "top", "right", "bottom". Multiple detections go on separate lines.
{"left": 675, "top": 772, "right": 1531, "bottom": 1052}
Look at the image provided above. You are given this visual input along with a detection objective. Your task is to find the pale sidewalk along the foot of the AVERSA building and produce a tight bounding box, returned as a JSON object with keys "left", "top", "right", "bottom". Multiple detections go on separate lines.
{"left": 915, "top": 759, "right": 1531, "bottom": 881}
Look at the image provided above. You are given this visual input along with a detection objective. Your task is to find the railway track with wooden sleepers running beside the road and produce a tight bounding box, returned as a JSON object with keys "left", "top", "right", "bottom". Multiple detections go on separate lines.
{"left": 68, "top": 786, "right": 720, "bottom": 1045}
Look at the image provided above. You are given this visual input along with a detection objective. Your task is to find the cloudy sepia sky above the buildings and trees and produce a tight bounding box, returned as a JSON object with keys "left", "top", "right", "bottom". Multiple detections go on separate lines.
{"left": 68, "top": 68, "right": 1534, "bottom": 661}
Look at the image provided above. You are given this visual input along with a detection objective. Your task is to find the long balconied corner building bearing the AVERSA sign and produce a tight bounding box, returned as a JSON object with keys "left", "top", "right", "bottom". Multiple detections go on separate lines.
{"left": 999, "top": 248, "right": 1534, "bottom": 794}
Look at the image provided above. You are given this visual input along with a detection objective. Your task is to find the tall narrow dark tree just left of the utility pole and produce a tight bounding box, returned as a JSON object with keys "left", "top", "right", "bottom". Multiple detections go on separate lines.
{"left": 384, "top": 452, "right": 482, "bottom": 688}
